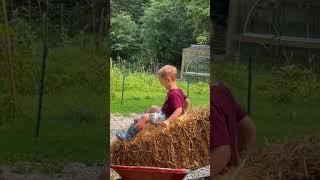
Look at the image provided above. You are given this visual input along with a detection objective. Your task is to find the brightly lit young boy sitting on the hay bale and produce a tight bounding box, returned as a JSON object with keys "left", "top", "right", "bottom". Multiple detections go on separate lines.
{"left": 116, "top": 65, "right": 190, "bottom": 141}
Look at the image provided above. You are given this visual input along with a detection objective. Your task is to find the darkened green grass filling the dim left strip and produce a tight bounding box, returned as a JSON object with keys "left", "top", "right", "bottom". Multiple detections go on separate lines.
{"left": 0, "top": 42, "right": 109, "bottom": 171}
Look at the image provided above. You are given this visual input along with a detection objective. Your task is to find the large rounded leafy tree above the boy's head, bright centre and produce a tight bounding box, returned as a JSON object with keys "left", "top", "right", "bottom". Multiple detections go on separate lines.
{"left": 141, "top": 0, "right": 194, "bottom": 66}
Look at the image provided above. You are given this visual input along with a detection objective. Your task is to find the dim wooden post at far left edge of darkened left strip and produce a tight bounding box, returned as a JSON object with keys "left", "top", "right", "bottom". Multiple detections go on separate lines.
{"left": 2, "top": 0, "right": 16, "bottom": 117}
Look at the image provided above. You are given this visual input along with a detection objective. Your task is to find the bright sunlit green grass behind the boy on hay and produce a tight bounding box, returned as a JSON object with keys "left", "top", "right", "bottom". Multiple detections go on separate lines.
{"left": 110, "top": 68, "right": 209, "bottom": 115}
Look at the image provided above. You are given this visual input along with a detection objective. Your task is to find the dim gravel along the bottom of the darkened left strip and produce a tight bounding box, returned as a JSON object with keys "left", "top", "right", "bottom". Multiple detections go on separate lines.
{"left": 0, "top": 162, "right": 104, "bottom": 180}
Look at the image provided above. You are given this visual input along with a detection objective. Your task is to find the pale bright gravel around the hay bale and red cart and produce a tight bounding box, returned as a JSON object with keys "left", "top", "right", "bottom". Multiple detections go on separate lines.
{"left": 110, "top": 114, "right": 210, "bottom": 180}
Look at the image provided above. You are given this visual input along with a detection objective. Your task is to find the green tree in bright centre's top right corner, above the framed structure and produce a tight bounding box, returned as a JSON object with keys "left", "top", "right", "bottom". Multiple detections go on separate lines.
{"left": 187, "top": 0, "right": 210, "bottom": 44}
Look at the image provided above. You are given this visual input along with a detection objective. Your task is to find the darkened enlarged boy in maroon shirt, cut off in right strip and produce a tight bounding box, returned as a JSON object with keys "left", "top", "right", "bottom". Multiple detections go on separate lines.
{"left": 210, "top": 80, "right": 256, "bottom": 177}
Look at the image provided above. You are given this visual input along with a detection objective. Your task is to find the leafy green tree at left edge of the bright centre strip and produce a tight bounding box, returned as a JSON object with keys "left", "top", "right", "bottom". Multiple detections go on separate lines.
{"left": 110, "top": 12, "right": 140, "bottom": 60}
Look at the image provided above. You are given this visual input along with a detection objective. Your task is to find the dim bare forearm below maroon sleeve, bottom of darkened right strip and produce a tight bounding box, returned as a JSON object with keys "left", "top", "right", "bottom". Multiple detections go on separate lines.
{"left": 210, "top": 145, "right": 231, "bottom": 177}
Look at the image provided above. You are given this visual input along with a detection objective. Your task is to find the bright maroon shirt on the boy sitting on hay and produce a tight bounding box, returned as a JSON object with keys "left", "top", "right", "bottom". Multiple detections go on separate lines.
{"left": 161, "top": 88, "right": 187, "bottom": 117}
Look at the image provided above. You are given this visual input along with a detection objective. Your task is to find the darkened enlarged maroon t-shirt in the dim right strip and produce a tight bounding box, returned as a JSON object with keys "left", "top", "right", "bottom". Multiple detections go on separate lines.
{"left": 210, "top": 83, "right": 247, "bottom": 163}
